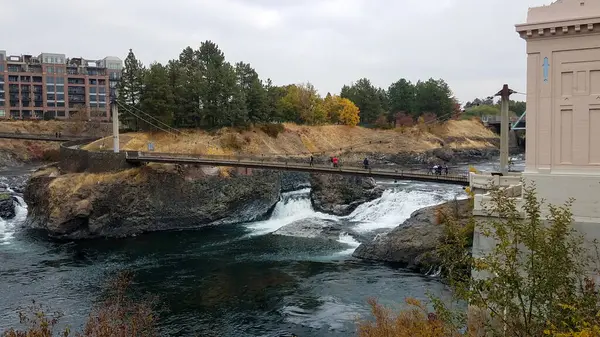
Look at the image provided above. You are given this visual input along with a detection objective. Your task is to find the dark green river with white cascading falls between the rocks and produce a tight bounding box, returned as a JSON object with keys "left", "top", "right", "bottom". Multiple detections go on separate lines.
{"left": 0, "top": 159, "right": 520, "bottom": 337}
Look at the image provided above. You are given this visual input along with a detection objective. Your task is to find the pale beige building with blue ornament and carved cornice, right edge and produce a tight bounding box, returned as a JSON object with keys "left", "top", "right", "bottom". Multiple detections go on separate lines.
{"left": 517, "top": 0, "right": 600, "bottom": 223}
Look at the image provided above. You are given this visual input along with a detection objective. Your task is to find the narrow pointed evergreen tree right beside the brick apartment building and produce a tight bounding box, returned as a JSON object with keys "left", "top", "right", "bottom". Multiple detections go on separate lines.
{"left": 117, "top": 49, "right": 144, "bottom": 128}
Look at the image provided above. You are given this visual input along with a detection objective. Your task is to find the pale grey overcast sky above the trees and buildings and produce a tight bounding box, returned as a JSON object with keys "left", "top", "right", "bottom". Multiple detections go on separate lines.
{"left": 0, "top": 0, "right": 551, "bottom": 103}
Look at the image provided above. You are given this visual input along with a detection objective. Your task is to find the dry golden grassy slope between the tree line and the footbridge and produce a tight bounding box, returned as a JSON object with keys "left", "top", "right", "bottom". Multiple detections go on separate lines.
{"left": 86, "top": 121, "right": 497, "bottom": 156}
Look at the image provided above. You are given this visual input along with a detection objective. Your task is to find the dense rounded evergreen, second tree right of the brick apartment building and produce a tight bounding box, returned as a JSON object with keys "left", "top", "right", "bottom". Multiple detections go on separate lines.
{"left": 141, "top": 63, "right": 174, "bottom": 127}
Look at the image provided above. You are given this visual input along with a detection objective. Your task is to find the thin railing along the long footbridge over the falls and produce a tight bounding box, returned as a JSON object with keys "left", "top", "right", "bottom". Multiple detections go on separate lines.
{"left": 126, "top": 151, "right": 469, "bottom": 181}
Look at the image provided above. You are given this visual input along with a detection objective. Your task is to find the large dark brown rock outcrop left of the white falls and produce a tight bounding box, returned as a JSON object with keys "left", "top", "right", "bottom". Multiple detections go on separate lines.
{"left": 24, "top": 165, "right": 281, "bottom": 239}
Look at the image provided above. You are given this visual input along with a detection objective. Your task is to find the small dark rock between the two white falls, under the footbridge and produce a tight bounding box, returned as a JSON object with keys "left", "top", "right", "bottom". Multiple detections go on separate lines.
{"left": 310, "top": 174, "right": 383, "bottom": 216}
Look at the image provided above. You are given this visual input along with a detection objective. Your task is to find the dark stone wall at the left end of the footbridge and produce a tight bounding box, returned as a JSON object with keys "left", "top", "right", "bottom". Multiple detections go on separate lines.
{"left": 59, "top": 139, "right": 132, "bottom": 173}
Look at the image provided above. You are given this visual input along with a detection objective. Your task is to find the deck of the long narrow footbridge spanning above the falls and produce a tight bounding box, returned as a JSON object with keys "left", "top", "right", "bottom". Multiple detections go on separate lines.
{"left": 126, "top": 151, "right": 469, "bottom": 186}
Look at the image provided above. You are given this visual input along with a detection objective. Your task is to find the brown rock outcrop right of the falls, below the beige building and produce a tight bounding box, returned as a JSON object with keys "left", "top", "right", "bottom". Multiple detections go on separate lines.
{"left": 353, "top": 200, "right": 472, "bottom": 271}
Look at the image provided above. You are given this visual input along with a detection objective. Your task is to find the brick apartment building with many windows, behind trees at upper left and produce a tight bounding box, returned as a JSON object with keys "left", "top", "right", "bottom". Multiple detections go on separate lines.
{"left": 0, "top": 50, "right": 123, "bottom": 120}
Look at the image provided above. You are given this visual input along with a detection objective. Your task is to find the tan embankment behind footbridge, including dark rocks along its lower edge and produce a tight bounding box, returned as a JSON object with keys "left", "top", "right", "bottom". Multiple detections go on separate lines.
{"left": 85, "top": 120, "right": 498, "bottom": 164}
